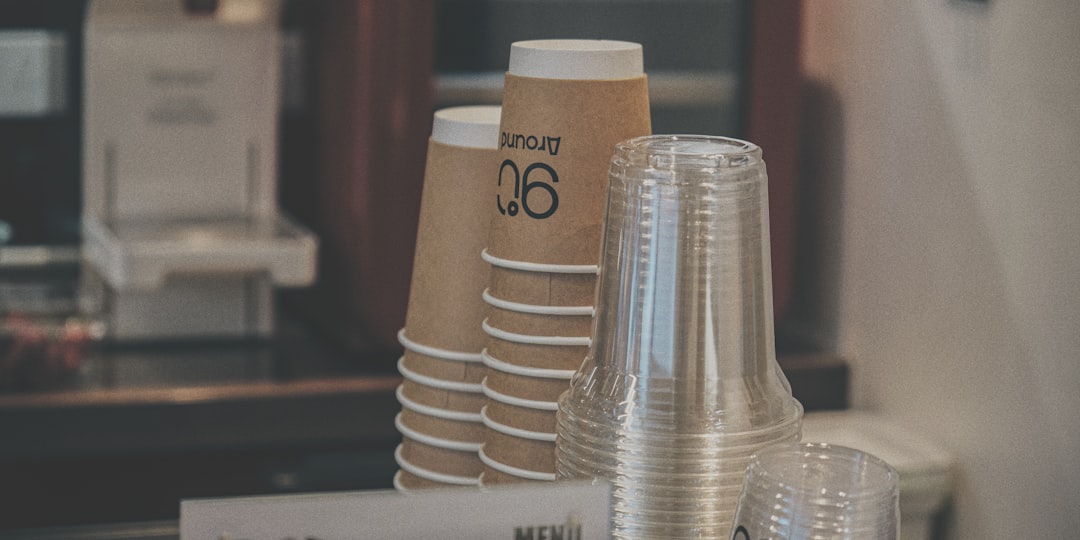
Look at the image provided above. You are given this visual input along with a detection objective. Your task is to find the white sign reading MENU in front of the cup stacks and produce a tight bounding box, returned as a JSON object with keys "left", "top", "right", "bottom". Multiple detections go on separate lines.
{"left": 180, "top": 483, "right": 610, "bottom": 540}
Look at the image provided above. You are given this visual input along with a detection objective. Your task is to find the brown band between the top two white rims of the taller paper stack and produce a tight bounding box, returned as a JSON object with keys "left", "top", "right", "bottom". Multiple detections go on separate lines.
{"left": 488, "top": 266, "right": 597, "bottom": 307}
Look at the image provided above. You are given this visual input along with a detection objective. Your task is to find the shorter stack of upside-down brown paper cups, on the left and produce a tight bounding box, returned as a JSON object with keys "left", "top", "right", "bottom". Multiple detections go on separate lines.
{"left": 394, "top": 106, "right": 500, "bottom": 490}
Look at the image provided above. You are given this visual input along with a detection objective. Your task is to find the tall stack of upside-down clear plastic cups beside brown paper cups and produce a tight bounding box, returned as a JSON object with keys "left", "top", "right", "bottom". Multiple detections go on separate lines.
{"left": 555, "top": 135, "right": 802, "bottom": 538}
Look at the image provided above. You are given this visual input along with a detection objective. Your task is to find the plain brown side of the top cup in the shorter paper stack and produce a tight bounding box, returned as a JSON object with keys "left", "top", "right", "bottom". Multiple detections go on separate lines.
{"left": 405, "top": 140, "right": 498, "bottom": 352}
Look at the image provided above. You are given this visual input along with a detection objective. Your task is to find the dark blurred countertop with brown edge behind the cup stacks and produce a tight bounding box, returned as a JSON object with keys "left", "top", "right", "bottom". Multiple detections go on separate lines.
{"left": 0, "top": 321, "right": 848, "bottom": 538}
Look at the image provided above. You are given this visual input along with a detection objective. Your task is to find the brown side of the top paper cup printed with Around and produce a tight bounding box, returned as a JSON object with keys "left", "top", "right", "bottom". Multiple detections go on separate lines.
{"left": 488, "top": 73, "right": 651, "bottom": 265}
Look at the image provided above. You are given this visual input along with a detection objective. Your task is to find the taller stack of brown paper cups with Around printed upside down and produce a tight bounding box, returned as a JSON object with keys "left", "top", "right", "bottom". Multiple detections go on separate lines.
{"left": 480, "top": 40, "right": 651, "bottom": 485}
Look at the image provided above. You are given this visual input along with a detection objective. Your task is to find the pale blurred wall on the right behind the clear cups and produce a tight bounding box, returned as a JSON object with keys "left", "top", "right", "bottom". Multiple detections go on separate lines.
{"left": 804, "top": 0, "right": 1080, "bottom": 540}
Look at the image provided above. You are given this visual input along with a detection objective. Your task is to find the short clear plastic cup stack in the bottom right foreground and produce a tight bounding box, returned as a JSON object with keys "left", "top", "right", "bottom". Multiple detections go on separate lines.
{"left": 730, "top": 443, "right": 900, "bottom": 540}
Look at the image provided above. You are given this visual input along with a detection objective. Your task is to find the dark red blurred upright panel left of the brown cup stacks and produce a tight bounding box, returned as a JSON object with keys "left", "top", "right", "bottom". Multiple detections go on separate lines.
{"left": 284, "top": 0, "right": 434, "bottom": 352}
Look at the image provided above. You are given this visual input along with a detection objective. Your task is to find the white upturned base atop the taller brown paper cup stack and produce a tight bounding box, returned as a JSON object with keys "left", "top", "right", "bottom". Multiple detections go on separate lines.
{"left": 509, "top": 39, "right": 645, "bottom": 80}
